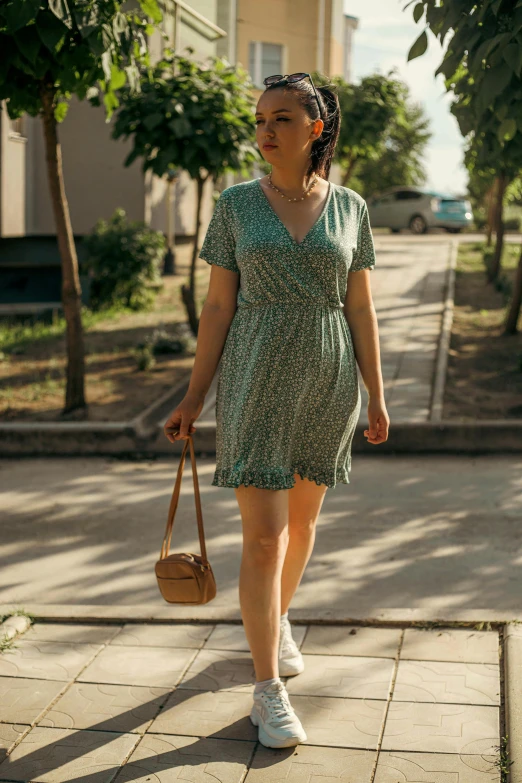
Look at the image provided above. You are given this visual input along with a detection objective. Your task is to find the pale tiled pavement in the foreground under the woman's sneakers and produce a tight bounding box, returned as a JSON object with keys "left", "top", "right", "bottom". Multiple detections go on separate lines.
{"left": 0, "top": 623, "right": 501, "bottom": 783}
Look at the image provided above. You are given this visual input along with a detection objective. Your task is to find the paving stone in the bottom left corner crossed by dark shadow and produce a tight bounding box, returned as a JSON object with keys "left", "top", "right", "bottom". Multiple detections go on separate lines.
{"left": 0, "top": 726, "right": 139, "bottom": 783}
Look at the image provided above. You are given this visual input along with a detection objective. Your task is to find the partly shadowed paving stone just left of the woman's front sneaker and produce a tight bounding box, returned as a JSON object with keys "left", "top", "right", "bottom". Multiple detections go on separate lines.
{"left": 147, "top": 688, "right": 257, "bottom": 740}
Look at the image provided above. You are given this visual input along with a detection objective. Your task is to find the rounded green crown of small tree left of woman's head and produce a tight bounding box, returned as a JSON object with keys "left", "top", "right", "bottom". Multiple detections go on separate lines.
{"left": 113, "top": 49, "right": 260, "bottom": 179}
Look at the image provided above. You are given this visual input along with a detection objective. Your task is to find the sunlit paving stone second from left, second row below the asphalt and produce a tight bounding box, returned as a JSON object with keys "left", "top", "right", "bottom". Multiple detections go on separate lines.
{"left": 78, "top": 645, "right": 194, "bottom": 687}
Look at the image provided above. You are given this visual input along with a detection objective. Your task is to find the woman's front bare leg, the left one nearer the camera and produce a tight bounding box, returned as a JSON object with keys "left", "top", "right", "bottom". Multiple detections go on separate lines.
{"left": 235, "top": 484, "right": 289, "bottom": 682}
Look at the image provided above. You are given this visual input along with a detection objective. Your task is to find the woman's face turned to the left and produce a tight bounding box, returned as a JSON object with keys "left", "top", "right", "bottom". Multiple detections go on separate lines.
{"left": 256, "top": 87, "right": 324, "bottom": 164}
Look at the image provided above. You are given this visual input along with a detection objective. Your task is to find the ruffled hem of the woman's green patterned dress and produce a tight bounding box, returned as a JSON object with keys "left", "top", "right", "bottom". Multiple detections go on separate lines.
{"left": 211, "top": 465, "right": 351, "bottom": 489}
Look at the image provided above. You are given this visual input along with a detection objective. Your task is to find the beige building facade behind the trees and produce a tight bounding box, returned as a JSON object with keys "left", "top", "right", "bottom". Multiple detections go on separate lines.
{"left": 0, "top": 0, "right": 357, "bottom": 305}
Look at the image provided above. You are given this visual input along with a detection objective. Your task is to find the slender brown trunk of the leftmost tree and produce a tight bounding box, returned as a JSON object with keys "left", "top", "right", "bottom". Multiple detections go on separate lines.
{"left": 41, "top": 85, "right": 87, "bottom": 417}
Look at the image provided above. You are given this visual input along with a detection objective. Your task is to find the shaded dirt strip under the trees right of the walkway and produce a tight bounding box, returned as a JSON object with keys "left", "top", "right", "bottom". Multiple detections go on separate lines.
{"left": 443, "top": 244, "right": 522, "bottom": 420}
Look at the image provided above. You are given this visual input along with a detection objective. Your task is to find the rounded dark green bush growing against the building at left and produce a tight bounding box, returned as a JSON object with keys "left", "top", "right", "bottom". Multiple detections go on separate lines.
{"left": 83, "top": 209, "right": 167, "bottom": 310}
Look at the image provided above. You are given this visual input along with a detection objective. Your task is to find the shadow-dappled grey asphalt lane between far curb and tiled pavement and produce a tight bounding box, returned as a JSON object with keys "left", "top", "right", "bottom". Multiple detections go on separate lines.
{"left": 0, "top": 451, "right": 522, "bottom": 622}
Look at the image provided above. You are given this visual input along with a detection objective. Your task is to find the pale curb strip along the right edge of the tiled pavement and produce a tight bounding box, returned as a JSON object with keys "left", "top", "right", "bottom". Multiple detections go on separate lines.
{"left": 504, "top": 623, "right": 522, "bottom": 783}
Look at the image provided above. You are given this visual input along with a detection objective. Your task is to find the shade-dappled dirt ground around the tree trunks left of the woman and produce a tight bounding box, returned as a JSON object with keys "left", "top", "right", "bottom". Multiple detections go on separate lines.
{"left": 0, "top": 262, "right": 206, "bottom": 422}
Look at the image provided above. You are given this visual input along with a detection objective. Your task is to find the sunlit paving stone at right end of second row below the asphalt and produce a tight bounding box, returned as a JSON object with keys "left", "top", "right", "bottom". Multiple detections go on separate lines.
{"left": 393, "top": 661, "right": 500, "bottom": 706}
